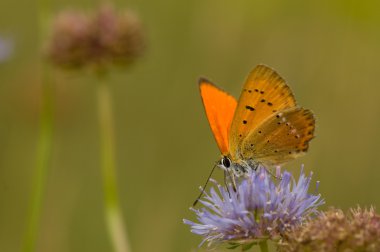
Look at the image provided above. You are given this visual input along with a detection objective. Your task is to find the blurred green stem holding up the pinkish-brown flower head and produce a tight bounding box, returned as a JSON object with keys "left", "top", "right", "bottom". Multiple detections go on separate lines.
{"left": 98, "top": 76, "right": 131, "bottom": 252}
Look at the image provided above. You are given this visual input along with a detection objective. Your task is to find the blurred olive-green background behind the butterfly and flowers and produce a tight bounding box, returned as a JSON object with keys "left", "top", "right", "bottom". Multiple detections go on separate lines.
{"left": 0, "top": 0, "right": 380, "bottom": 252}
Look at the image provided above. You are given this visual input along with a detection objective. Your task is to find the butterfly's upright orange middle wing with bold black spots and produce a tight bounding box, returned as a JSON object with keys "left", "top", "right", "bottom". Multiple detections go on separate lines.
{"left": 229, "top": 65, "right": 296, "bottom": 158}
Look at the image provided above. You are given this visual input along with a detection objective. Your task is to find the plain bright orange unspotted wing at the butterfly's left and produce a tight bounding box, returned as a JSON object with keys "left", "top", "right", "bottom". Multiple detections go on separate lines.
{"left": 199, "top": 78, "right": 237, "bottom": 155}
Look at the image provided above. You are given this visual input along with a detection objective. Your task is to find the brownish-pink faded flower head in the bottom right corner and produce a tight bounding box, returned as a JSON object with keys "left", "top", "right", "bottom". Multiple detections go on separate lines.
{"left": 279, "top": 207, "right": 380, "bottom": 252}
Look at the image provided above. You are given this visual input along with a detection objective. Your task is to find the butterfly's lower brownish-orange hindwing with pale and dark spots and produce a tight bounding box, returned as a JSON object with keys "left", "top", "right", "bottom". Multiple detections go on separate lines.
{"left": 240, "top": 107, "right": 315, "bottom": 166}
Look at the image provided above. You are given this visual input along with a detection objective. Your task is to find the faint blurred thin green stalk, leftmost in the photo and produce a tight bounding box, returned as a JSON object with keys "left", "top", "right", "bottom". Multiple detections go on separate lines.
{"left": 22, "top": 0, "right": 53, "bottom": 252}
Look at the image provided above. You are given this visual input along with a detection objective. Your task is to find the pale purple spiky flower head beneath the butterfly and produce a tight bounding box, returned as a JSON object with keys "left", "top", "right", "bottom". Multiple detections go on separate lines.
{"left": 184, "top": 168, "right": 324, "bottom": 246}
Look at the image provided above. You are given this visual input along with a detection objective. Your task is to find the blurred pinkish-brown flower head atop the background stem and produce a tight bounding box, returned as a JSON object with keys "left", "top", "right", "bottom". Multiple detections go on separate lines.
{"left": 48, "top": 5, "right": 145, "bottom": 68}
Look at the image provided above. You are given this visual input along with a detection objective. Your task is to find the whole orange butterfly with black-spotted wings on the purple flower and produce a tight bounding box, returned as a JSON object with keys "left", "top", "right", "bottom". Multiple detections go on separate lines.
{"left": 199, "top": 65, "right": 315, "bottom": 177}
